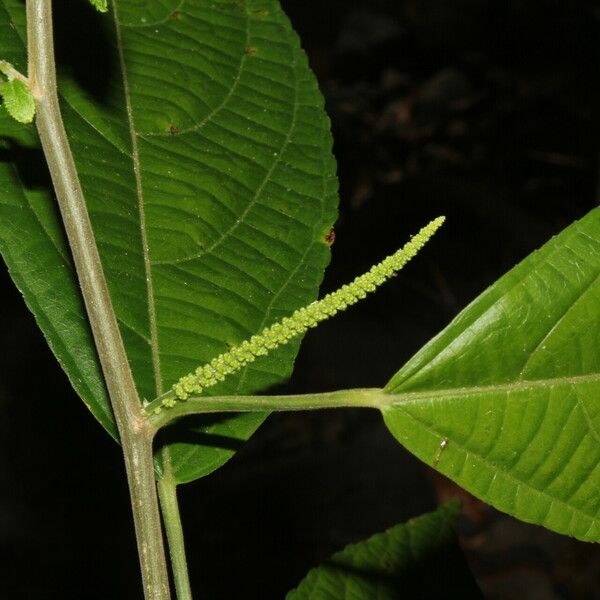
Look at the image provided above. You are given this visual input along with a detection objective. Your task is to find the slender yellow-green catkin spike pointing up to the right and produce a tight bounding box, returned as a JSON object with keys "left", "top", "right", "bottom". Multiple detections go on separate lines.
{"left": 162, "top": 217, "right": 444, "bottom": 407}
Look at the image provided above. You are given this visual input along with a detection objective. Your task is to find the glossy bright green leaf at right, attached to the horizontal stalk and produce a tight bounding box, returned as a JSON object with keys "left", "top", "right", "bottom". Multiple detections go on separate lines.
{"left": 383, "top": 209, "right": 600, "bottom": 542}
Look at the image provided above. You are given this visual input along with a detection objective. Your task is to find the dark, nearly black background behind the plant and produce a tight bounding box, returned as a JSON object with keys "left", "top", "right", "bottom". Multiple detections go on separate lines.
{"left": 0, "top": 0, "right": 600, "bottom": 600}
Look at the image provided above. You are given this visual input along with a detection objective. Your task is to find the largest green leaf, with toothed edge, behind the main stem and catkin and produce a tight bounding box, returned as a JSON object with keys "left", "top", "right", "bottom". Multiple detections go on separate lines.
{"left": 0, "top": 0, "right": 337, "bottom": 481}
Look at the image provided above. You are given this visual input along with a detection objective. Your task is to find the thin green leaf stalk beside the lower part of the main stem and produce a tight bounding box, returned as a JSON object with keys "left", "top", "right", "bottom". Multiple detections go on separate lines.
{"left": 157, "top": 448, "right": 192, "bottom": 600}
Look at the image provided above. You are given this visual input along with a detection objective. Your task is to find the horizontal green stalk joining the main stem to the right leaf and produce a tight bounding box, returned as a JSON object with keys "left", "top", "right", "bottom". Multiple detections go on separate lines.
{"left": 146, "top": 388, "right": 396, "bottom": 429}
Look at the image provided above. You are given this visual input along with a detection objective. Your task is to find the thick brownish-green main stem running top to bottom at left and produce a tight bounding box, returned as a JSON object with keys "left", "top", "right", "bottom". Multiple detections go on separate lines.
{"left": 27, "top": 0, "right": 170, "bottom": 600}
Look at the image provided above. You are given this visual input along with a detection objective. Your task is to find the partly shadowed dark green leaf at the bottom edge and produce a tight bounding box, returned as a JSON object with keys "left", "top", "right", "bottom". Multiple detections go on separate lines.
{"left": 286, "top": 501, "right": 482, "bottom": 600}
